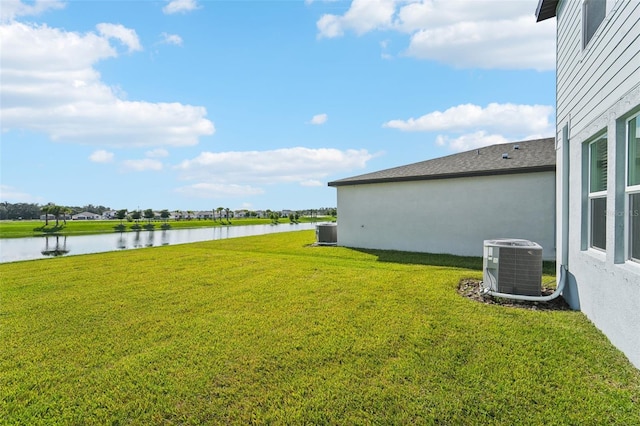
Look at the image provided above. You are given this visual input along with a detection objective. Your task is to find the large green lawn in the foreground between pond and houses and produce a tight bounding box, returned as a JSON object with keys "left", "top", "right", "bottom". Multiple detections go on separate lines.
{"left": 0, "top": 231, "right": 640, "bottom": 425}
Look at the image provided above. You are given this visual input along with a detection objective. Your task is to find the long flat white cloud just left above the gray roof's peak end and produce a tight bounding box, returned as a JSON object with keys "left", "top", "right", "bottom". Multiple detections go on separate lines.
{"left": 176, "top": 147, "right": 374, "bottom": 184}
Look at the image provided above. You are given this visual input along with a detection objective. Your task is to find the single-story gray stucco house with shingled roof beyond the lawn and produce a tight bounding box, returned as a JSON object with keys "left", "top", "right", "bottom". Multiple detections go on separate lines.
{"left": 329, "top": 138, "right": 556, "bottom": 259}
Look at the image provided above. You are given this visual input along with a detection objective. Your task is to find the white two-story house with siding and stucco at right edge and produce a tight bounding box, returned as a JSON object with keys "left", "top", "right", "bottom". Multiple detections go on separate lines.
{"left": 536, "top": 0, "right": 640, "bottom": 368}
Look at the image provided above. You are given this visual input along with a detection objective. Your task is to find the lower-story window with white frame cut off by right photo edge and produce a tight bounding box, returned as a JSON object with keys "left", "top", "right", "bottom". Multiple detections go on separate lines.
{"left": 626, "top": 114, "right": 640, "bottom": 261}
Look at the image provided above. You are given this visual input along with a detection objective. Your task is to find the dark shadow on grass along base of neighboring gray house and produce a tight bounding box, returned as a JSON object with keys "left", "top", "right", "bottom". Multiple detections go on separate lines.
{"left": 352, "top": 248, "right": 556, "bottom": 275}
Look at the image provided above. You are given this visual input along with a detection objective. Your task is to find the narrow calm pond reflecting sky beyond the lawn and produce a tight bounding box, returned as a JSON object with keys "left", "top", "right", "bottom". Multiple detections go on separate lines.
{"left": 0, "top": 223, "right": 317, "bottom": 263}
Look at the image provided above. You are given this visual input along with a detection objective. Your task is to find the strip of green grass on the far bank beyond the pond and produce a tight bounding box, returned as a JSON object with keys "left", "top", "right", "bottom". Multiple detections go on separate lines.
{"left": 0, "top": 217, "right": 335, "bottom": 238}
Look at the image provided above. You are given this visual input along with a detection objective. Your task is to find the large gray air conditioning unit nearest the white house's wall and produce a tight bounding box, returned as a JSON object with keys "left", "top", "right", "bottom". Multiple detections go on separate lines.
{"left": 483, "top": 238, "right": 542, "bottom": 296}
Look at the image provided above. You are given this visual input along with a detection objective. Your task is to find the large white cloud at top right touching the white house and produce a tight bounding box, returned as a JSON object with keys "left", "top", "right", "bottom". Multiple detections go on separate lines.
{"left": 316, "top": 0, "right": 555, "bottom": 70}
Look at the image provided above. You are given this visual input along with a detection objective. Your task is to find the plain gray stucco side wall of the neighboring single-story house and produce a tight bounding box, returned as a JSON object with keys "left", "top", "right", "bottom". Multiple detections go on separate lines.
{"left": 337, "top": 172, "right": 555, "bottom": 259}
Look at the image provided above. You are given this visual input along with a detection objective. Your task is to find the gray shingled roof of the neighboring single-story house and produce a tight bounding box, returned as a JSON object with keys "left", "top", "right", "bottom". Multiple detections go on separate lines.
{"left": 328, "top": 138, "right": 556, "bottom": 186}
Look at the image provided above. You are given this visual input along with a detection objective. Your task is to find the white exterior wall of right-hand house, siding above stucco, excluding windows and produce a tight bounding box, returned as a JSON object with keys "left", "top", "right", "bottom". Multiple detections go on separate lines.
{"left": 557, "top": 0, "right": 640, "bottom": 368}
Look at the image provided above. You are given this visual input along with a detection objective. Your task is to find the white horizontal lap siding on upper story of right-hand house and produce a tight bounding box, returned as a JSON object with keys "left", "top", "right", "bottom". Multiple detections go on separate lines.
{"left": 557, "top": 1, "right": 640, "bottom": 134}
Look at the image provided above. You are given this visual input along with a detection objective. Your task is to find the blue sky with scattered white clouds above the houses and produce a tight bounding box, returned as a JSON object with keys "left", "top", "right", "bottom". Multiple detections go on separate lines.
{"left": 0, "top": 0, "right": 556, "bottom": 211}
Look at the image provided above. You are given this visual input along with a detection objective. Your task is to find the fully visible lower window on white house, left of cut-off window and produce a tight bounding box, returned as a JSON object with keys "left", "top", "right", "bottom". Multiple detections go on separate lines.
{"left": 589, "top": 135, "right": 607, "bottom": 250}
